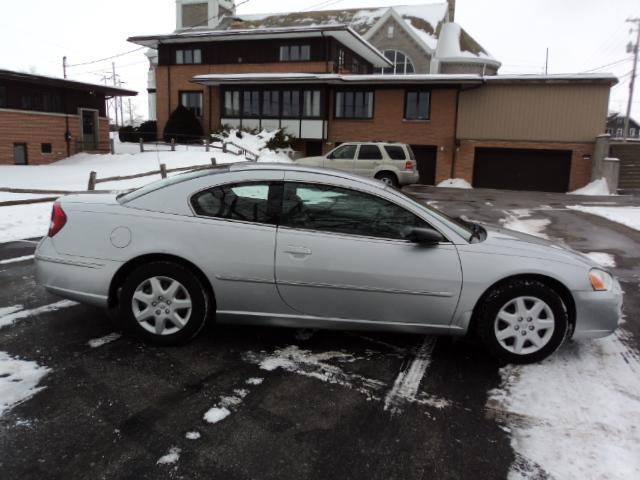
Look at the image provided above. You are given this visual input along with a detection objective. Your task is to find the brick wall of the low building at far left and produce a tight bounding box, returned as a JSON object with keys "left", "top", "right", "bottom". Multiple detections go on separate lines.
{"left": 0, "top": 110, "right": 109, "bottom": 165}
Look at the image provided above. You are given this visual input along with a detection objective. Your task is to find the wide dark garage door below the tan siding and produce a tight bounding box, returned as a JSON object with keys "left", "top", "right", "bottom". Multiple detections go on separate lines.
{"left": 473, "top": 148, "right": 571, "bottom": 192}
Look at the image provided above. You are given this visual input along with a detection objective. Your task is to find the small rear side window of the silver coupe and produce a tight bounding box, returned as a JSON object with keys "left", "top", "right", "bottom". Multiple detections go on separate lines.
{"left": 191, "top": 182, "right": 277, "bottom": 224}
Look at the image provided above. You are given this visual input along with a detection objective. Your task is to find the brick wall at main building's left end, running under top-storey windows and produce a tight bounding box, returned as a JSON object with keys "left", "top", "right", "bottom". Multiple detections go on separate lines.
{"left": 156, "top": 62, "right": 333, "bottom": 136}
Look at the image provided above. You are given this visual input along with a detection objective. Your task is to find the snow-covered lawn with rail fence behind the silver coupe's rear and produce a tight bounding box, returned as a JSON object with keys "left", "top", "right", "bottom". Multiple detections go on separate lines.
{"left": 0, "top": 130, "right": 291, "bottom": 243}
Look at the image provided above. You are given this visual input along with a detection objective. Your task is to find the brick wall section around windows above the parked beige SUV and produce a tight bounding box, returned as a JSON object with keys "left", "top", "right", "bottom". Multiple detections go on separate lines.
{"left": 324, "top": 89, "right": 456, "bottom": 182}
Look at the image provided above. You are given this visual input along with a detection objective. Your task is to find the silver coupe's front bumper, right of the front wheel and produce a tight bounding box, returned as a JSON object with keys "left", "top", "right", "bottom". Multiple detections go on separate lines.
{"left": 572, "top": 278, "right": 623, "bottom": 339}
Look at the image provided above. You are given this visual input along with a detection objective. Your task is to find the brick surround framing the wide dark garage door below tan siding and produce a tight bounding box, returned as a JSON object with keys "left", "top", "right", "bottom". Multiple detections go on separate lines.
{"left": 454, "top": 140, "right": 595, "bottom": 191}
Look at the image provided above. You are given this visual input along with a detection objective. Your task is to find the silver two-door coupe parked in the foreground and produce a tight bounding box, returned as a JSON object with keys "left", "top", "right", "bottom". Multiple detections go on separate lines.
{"left": 36, "top": 164, "right": 622, "bottom": 363}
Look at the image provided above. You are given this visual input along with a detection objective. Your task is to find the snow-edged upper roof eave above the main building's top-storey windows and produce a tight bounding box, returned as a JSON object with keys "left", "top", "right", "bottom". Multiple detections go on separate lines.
{"left": 128, "top": 24, "right": 392, "bottom": 67}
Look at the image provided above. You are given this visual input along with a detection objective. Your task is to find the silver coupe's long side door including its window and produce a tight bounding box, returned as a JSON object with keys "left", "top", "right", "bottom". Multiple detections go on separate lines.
{"left": 275, "top": 176, "right": 462, "bottom": 326}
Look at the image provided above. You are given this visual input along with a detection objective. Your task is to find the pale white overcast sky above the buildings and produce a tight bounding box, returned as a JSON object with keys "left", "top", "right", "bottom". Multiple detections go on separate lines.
{"left": 0, "top": 0, "right": 640, "bottom": 120}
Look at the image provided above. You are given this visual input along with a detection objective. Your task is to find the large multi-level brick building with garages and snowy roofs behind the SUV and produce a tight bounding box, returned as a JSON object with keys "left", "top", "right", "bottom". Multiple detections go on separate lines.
{"left": 129, "top": 0, "right": 617, "bottom": 191}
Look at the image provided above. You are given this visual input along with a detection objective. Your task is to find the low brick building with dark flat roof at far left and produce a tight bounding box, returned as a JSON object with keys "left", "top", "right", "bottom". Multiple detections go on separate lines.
{"left": 0, "top": 70, "right": 136, "bottom": 165}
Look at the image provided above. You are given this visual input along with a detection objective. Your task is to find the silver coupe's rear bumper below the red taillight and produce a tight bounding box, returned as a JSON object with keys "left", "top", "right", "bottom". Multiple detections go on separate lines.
{"left": 35, "top": 238, "right": 121, "bottom": 307}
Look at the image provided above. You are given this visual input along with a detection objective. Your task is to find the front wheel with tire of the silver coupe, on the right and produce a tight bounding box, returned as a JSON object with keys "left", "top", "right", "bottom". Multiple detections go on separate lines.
{"left": 475, "top": 280, "right": 569, "bottom": 364}
